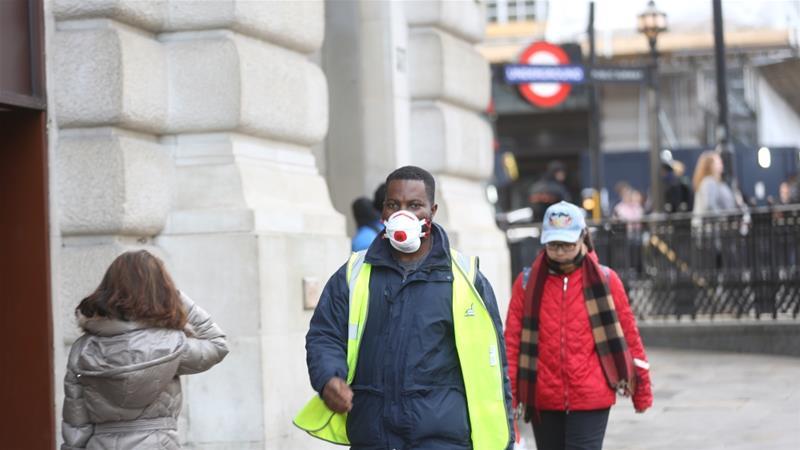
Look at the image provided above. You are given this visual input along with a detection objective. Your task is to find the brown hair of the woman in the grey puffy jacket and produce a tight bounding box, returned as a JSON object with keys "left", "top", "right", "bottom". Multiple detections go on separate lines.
{"left": 75, "top": 250, "right": 186, "bottom": 330}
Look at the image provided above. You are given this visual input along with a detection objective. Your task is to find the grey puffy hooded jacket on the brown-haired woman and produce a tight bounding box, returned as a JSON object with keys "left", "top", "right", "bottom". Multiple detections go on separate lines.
{"left": 61, "top": 293, "right": 228, "bottom": 450}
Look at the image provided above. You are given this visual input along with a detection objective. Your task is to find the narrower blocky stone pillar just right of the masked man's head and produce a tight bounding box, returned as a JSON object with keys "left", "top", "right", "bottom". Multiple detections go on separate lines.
{"left": 406, "top": 1, "right": 511, "bottom": 308}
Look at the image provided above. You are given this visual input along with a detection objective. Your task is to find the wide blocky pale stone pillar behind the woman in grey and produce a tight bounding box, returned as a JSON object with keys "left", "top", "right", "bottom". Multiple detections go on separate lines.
{"left": 48, "top": 0, "right": 348, "bottom": 449}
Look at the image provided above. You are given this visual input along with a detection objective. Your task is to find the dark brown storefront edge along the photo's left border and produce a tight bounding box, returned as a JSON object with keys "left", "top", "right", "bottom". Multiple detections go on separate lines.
{"left": 0, "top": 0, "right": 55, "bottom": 450}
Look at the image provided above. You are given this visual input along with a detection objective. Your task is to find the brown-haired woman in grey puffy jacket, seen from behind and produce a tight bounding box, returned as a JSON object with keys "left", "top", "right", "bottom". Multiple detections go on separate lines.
{"left": 61, "top": 250, "right": 228, "bottom": 450}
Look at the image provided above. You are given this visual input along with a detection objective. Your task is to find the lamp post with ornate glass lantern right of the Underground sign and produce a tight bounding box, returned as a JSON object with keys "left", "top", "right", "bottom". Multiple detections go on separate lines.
{"left": 638, "top": 0, "right": 667, "bottom": 213}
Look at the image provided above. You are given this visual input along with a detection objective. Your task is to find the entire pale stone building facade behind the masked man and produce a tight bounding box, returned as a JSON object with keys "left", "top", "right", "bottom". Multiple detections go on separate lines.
{"left": 37, "top": 0, "right": 510, "bottom": 450}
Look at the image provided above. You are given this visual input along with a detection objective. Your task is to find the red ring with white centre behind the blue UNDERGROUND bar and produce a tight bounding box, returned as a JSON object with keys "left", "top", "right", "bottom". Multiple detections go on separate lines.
{"left": 519, "top": 41, "right": 572, "bottom": 108}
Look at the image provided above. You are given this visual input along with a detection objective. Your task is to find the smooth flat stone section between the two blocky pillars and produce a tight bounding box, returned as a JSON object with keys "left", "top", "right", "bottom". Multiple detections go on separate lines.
{"left": 322, "top": 0, "right": 410, "bottom": 229}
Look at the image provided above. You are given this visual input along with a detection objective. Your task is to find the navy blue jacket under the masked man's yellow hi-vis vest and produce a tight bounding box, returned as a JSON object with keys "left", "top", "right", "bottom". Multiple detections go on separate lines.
{"left": 306, "top": 224, "right": 513, "bottom": 450}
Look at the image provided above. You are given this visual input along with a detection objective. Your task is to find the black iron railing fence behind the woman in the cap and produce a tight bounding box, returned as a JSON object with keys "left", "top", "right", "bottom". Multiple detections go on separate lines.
{"left": 507, "top": 205, "right": 800, "bottom": 319}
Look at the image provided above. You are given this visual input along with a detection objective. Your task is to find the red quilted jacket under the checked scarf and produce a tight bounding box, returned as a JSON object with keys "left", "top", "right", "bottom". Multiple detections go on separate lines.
{"left": 505, "top": 253, "right": 653, "bottom": 411}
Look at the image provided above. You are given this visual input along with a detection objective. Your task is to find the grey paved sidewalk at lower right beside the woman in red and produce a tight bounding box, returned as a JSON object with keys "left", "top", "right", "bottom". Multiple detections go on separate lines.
{"left": 521, "top": 348, "right": 800, "bottom": 450}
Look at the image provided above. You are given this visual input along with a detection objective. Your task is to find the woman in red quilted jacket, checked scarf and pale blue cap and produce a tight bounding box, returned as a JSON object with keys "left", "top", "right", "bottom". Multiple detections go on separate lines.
{"left": 505, "top": 202, "right": 653, "bottom": 450}
